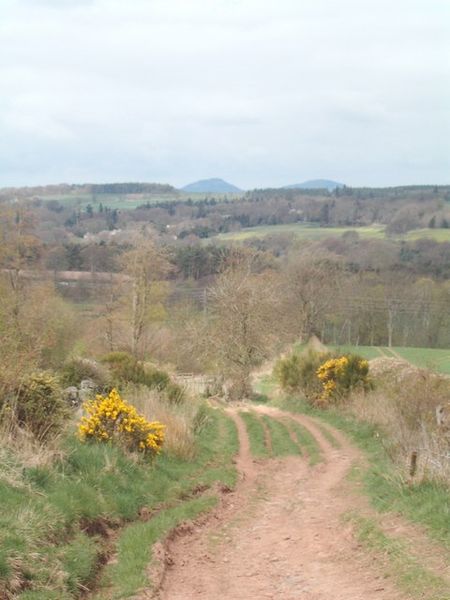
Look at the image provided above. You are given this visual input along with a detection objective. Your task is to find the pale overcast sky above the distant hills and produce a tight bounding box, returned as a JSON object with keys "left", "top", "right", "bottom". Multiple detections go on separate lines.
{"left": 0, "top": 0, "right": 450, "bottom": 188}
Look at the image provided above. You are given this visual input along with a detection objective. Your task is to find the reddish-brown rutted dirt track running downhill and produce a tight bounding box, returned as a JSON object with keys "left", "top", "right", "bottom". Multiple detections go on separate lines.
{"left": 160, "top": 406, "right": 405, "bottom": 600}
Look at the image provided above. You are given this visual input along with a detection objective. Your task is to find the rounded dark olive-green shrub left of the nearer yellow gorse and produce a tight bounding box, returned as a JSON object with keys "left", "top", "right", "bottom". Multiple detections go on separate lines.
{"left": 10, "top": 371, "right": 70, "bottom": 440}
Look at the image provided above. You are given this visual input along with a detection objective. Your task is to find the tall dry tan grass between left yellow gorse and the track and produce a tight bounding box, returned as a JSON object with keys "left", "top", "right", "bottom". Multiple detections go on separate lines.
{"left": 123, "top": 384, "right": 202, "bottom": 460}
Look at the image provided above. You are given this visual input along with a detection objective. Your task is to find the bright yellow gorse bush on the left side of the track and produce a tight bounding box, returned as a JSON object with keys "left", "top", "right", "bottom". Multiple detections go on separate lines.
{"left": 78, "top": 389, "right": 165, "bottom": 456}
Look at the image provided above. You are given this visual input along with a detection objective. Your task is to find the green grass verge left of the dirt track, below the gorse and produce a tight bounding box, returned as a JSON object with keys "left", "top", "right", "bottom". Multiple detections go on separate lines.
{"left": 0, "top": 409, "right": 238, "bottom": 600}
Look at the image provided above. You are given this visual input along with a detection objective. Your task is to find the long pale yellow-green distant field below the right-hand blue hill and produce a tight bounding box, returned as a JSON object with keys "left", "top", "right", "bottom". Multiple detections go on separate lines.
{"left": 217, "top": 223, "right": 385, "bottom": 242}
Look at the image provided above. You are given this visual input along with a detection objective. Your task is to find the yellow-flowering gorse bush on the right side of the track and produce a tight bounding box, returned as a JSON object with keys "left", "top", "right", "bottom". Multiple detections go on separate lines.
{"left": 316, "top": 354, "right": 369, "bottom": 403}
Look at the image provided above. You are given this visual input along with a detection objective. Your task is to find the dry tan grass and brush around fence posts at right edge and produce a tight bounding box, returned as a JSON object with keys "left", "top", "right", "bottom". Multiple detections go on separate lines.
{"left": 352, "top": 359, "right": 450, "bottom": 483}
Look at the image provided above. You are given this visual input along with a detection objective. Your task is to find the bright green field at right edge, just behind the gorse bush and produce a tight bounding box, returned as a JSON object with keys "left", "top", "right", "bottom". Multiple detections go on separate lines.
{"left": 295, "top": 344, "right": 450, "bottom": 375}
